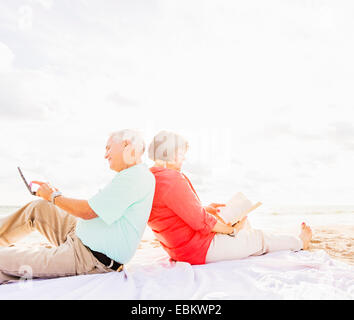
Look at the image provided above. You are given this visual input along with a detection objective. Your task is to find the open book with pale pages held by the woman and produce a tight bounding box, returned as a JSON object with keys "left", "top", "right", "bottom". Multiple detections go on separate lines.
{"left": 218, "top": 192, "right": 262, "bottom": 226}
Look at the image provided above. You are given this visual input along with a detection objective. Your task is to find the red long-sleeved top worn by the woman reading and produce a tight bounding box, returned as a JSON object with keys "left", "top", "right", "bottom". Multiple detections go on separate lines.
{"left": 148, "top": 167, "right": 217, "bottom": 264}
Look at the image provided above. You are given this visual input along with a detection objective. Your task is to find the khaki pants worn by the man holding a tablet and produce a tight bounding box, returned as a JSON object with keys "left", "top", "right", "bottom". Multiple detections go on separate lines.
{"left": 0, "top": 200, "right": 113, "bottom": 284}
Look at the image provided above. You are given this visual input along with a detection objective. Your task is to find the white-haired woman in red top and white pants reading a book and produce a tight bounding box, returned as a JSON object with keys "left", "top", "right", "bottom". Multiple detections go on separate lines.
{"left": 148, "top": 131, "right": 312, "bottom": 264}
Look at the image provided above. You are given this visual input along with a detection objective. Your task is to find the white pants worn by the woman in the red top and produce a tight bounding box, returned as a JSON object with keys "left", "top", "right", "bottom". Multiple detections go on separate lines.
{"left": 205, "top": 226, "right": 303, "bottom": 263}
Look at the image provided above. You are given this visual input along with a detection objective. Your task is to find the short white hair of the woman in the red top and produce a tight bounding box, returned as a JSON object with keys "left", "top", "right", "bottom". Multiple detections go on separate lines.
{"left": 149, "top": 131, "right": 188, "bottom": 162}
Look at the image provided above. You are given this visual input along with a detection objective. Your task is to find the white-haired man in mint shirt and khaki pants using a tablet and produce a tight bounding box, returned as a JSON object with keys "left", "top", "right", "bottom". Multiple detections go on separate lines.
{"left": 0, "top": 130, "right": 155, "bottom": 284}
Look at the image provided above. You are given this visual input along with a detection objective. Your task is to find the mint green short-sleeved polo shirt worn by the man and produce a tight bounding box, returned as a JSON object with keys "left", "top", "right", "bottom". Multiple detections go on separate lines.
{"left": 76, "top": 163, "right": 155, "bottom": 264}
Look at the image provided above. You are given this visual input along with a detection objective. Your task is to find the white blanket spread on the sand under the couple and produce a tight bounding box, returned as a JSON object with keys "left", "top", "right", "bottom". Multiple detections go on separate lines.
{"left": 0, "top": 247, "right": 354, "bottom": 300}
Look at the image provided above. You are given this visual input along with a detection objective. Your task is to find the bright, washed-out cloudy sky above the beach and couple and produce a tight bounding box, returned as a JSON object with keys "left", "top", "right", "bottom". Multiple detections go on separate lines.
{"left": 0, "top": 0, "right": 354, "bottom": 205}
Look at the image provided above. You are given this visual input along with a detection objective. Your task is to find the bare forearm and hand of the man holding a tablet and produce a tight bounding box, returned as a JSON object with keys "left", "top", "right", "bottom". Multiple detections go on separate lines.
{"left": 32, "top": 181, "right": 98, "bottom": 220}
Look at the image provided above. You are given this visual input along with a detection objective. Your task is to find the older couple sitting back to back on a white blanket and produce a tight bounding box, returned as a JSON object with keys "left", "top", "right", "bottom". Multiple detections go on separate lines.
{"left": 0, "top": 129, "right": 311, "bottom": 284}
